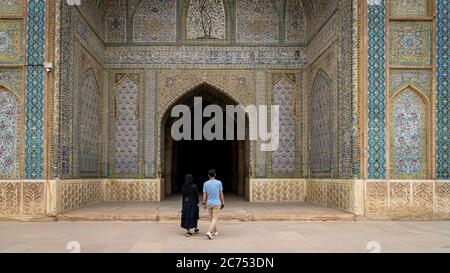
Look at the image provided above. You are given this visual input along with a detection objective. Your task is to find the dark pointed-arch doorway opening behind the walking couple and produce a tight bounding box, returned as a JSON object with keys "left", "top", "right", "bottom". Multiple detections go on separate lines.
{"left": 162, "top": 84, "right": 248, "bottom": 199}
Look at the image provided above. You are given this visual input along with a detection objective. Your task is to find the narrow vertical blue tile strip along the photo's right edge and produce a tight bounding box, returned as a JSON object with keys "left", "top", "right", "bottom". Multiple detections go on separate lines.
{"left": 436, "top": 0, "right": 450, "bottom": 179}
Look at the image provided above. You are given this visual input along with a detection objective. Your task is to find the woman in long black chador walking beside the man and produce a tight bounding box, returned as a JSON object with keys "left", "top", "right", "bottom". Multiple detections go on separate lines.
{"left": 181, "top": 174, "right": 199, "bottom": 237}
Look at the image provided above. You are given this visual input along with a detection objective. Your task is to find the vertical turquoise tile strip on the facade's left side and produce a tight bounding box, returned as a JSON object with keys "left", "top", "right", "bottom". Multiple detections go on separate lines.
{"left": 25, "top": 0, "right": 46, "bottom": 179}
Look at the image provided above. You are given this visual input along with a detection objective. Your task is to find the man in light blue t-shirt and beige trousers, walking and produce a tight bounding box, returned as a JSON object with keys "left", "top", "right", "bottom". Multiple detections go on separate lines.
{"left": 203, "top": 169, "right": 225, "bottom": 239}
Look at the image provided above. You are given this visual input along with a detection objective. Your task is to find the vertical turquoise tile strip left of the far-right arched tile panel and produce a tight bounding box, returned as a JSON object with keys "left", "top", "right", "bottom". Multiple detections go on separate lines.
{"left": 367, "top": 0, "right": 386, "bottom": 179}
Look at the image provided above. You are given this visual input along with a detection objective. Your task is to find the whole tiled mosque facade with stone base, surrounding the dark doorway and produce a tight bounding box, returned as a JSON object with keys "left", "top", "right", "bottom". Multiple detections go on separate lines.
{"left": 0, "top": 0, "right": 450, "bottom": 219}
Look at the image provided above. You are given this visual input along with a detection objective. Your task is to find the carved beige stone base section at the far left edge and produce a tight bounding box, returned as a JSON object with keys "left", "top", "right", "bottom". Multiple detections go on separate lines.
{"left": 0, "top": 180, "right": 46, "bottom": 218}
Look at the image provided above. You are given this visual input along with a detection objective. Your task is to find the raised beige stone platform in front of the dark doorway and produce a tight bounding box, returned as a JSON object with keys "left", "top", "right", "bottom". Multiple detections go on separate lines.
{"left": 57, "top": 195, "right": 355, "bottom": 221}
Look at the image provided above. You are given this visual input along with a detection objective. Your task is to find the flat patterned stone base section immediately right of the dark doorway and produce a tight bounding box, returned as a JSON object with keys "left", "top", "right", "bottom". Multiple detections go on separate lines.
{"left": 250, "top": 178, "right": 306, "bottom": 202}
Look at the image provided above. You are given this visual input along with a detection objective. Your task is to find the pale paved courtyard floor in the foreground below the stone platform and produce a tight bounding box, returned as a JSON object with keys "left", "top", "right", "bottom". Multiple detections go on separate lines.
{"left": 0, "top": 221, "right": 450, "bottom": 253}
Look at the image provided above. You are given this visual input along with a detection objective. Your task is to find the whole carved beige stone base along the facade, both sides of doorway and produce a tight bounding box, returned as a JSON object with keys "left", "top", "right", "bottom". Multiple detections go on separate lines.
{"left": 0, "top": 179, "right": 450, "bottom": 220}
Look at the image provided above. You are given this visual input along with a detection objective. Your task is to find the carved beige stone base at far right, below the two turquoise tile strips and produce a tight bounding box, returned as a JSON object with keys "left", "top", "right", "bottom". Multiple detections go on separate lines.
{"left": 365, "top": 180, "right": 450, "bottom": 219}
